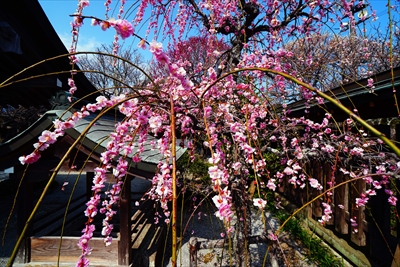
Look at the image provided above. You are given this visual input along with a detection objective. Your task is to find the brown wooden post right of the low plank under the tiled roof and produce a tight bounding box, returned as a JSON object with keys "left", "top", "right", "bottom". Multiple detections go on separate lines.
{"left": 118, "top": 176, "right": 132, "bottom": 266}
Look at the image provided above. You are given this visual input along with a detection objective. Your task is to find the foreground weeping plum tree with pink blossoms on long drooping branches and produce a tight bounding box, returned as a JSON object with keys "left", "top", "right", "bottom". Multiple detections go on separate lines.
{"left": 7, "top": 0, "right": 400, "bottom": 266}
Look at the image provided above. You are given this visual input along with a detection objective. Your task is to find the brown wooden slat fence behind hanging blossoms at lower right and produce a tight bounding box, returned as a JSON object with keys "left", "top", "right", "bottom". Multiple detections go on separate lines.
{"left": 279, "top": 161, "right": 400, "bottom": 266}
